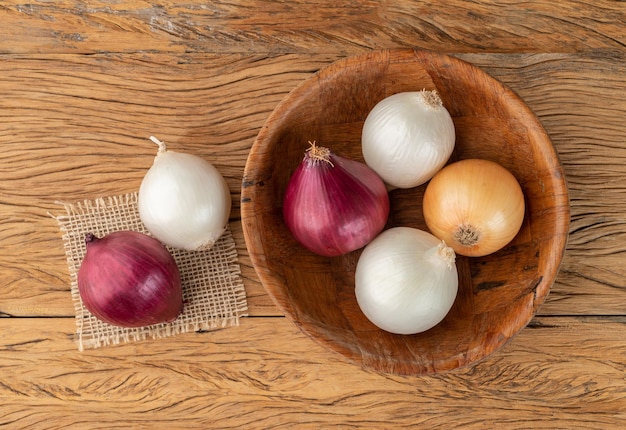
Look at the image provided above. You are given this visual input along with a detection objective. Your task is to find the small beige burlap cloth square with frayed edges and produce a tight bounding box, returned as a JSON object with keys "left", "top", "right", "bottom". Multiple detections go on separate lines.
{"left": 53, "top": 193, "right": 248, "bottom": 351}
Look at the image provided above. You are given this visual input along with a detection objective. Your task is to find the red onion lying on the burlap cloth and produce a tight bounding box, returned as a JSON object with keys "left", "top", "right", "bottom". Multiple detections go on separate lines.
{"left": 78, "top": 231, "right": 183, "bottom": 327}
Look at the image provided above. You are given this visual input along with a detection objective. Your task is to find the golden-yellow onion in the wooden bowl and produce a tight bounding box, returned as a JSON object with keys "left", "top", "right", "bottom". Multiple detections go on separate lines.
{"left": 423, "top": 159, "right": 525, "bottom": 257}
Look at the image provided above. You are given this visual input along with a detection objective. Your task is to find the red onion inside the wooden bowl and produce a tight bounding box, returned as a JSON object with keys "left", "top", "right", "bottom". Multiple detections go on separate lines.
{"left": 283, "top": 143, "right": 389, "bottom": 257}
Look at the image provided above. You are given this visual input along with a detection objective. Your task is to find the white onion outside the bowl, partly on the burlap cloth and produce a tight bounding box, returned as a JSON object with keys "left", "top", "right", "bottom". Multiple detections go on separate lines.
{"left": 138, "top": 137, "right": 232, "bottom": 251}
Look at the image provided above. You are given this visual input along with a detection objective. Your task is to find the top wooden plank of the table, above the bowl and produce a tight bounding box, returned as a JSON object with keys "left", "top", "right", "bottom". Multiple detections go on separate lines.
{"left": 0, "top": 0, "right": 626, "bottom": 54}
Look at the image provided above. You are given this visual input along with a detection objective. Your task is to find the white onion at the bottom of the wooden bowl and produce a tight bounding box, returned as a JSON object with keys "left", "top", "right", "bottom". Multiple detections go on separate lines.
{"left": 355, "top": 227, "right": 458, "bottom": 334}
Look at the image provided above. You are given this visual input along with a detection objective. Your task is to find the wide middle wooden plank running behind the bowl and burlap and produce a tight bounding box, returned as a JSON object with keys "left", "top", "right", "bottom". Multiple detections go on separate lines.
{"left": 0, "top": 53, "right": 626, "bottom": 316}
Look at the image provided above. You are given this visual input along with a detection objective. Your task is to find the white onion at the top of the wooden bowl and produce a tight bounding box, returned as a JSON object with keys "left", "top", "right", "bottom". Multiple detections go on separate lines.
{"left": 361, "top": 90, "right": 456, "bottom": 188}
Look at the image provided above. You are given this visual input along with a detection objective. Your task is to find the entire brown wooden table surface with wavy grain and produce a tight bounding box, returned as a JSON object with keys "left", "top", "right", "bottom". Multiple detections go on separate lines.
{"left": 0, "top": 0, "right": 626, "bottom": 429}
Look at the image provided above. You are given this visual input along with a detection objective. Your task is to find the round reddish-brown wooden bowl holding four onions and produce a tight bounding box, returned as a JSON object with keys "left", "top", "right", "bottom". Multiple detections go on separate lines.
{"left": 241, "top": 49, "right": 569, "bottom": 374}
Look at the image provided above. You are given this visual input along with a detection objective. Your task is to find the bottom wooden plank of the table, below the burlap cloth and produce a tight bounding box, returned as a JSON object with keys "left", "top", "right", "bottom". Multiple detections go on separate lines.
{"left": 0, "top": 317, "right": 626, "bottom": 430}
